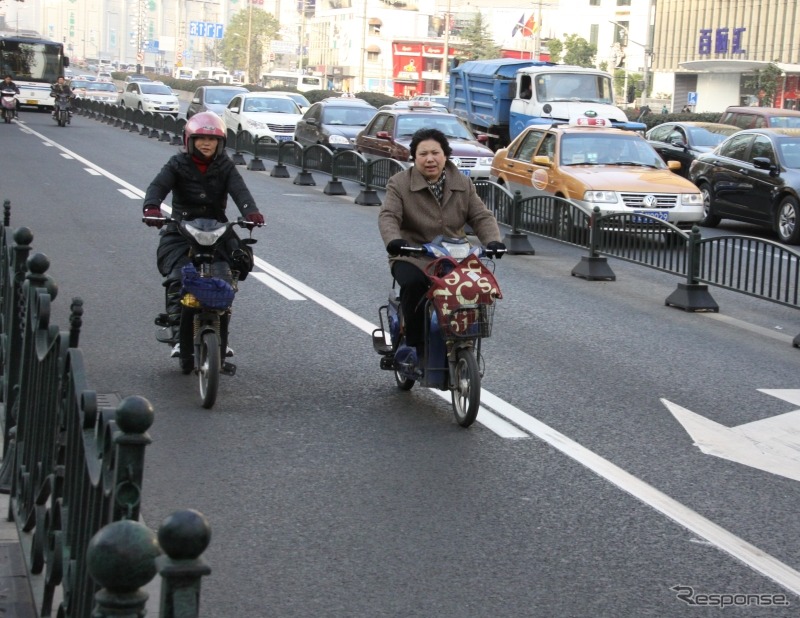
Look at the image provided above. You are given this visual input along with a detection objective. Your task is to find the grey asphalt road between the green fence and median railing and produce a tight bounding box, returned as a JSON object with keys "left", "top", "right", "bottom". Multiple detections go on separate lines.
{"left": 0, "top": 112, "right": 800, "bottom": 618}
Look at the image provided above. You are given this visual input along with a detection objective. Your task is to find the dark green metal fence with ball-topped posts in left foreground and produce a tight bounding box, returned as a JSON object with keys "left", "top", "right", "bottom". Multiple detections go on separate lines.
{"left": 0, "top": 200, "right": 210, "bottom": 618}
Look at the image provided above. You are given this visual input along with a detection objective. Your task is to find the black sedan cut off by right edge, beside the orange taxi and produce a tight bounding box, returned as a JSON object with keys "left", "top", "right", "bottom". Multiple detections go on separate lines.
{"left": 689, "top": 129, "right": 800, "bottom": 245}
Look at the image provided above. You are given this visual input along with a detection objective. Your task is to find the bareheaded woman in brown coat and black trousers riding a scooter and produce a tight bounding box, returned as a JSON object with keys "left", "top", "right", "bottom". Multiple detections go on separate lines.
{"left": 378, "top": 129, "right": 506, "bottom": 358}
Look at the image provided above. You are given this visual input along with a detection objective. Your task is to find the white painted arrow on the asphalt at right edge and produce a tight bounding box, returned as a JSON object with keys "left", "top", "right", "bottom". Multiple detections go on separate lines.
{"left": 661, "top": 389, "right": 800, "bottom": 481}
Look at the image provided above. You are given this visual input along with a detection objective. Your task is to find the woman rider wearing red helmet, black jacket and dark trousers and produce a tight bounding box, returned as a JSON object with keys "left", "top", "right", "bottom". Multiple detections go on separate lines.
{"left": 143, "top": 112, "right": 264, "bottom": 358}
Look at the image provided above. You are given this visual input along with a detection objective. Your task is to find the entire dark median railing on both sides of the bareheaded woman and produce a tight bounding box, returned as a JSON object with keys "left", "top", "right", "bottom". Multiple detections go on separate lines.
{"left": 70, "top": 104, "right": 800, "bottom": 347}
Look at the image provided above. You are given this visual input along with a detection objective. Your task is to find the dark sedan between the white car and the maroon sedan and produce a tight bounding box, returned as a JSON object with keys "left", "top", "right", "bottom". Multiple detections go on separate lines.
{"left": 294, "top": 98, "right": 378, "bottom": 151}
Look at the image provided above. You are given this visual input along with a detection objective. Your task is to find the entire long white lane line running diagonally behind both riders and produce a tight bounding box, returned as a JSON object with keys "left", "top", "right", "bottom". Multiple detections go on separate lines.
{"left": 32, "top": 131, "right": 800, "bottom": 595}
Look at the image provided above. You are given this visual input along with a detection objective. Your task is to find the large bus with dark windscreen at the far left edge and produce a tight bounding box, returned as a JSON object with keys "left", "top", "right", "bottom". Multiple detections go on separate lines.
{"left": 0, "top": 32, "right": 69, "bottom": 108}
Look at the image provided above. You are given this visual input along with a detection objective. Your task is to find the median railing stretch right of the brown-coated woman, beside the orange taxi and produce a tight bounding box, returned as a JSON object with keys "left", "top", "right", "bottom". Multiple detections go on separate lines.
{"left": 475, "top": 180, "right": 800, "bottom": 340}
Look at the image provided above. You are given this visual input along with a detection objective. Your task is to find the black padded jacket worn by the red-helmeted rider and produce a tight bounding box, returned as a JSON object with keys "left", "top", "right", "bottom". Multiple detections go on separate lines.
{"left": 144, "top": 152, "right": 259, "bottom": 221}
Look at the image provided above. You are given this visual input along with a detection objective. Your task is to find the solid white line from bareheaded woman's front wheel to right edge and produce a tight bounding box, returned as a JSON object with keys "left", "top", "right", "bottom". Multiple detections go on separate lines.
{"left": 481, "top": 391, "right": 800, "bottom": 595}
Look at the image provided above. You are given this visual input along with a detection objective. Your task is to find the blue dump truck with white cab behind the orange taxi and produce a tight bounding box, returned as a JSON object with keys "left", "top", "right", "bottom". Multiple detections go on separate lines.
{"left": 449, "top": 58, "right": 645, "bottom": 150}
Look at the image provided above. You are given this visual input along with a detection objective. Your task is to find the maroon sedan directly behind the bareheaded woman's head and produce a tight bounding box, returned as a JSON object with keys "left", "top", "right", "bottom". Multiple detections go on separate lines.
{"left": 356, "top": 108, "right": 493, "bottom": 178}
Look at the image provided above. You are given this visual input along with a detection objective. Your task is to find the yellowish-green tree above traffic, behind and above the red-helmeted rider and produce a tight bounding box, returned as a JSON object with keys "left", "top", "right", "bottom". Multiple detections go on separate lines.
{"left": 218, "top": 7, "right": 281, "bottom": 84}
